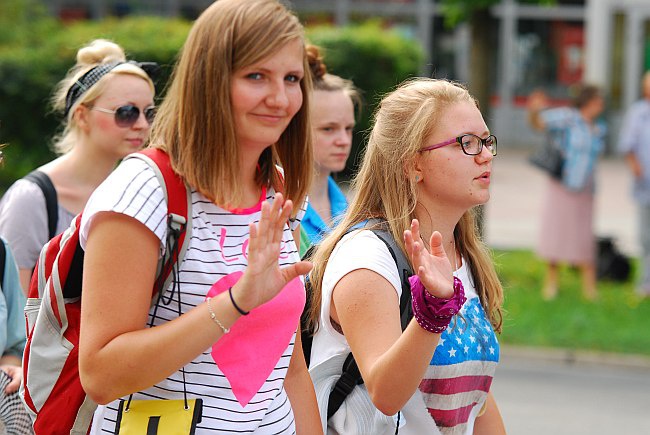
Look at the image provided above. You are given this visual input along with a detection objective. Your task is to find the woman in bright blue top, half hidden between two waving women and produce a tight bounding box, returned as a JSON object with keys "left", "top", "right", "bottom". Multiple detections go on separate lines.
{"left": 300, "top": 45, "right": 361, "bottom": 253}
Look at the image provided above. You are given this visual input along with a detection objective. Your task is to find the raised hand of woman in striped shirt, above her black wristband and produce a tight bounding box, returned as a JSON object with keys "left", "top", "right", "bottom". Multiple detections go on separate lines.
{"left": 232, "top": 193, "right": 312, "bottom": 311}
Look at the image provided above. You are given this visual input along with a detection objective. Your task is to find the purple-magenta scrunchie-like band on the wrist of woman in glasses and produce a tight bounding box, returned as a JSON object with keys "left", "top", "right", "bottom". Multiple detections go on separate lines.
{"left": 409, "top": 275, "right": 467, "bottom": 334}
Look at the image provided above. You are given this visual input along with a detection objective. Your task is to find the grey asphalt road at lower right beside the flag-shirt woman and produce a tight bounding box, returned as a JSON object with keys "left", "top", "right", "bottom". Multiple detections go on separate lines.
{"left": 492, "top": 349, "right": 650, "bottom": 435}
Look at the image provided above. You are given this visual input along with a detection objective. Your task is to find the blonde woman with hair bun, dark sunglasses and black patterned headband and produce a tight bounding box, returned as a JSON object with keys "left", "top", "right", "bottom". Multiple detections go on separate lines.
{"left": 0, "top": 39, "right": 155, "bottom": 292}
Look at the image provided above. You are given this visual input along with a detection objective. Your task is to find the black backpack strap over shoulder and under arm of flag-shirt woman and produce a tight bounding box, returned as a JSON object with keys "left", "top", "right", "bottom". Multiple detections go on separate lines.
{"left": 327, "top": 223, "right": 413, "bottom": 420}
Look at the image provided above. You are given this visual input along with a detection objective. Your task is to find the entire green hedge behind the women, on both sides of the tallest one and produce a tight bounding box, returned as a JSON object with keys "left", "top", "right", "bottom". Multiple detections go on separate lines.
{"left": 0, "top": 12, "right": 423, "bottom": 187}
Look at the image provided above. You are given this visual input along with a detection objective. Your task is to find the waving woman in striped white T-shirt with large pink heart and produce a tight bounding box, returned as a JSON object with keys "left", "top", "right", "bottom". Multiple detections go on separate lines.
{"left": 79, "top": 0, "right": 321, "bottom": 434}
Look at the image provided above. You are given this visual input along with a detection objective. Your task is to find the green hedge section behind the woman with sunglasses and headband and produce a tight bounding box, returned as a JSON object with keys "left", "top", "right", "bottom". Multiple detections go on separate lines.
{"left": 0, "top": 12, "right": 190, "bottom": 186}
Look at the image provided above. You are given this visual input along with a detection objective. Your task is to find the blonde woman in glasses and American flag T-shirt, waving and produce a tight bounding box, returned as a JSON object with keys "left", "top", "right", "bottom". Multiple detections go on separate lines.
{"left": 310, "top": 78, "right": 505, "bottom": 435}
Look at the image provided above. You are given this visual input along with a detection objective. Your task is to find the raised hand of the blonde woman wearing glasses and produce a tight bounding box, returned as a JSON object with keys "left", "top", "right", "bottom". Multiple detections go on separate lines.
{"left": 404, "top": 219, "right": 454, "bottom": 299}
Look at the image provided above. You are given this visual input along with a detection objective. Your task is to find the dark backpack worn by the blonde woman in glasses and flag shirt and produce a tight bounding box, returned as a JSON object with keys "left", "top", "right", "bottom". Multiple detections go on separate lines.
{"left": 300, "top": 219, "right": 413, "bottom": 420}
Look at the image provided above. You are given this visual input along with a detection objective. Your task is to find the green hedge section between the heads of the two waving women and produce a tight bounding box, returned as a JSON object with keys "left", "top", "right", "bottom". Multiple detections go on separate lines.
{"left": 307, "top": 22, "right": 424, "bottom": 176}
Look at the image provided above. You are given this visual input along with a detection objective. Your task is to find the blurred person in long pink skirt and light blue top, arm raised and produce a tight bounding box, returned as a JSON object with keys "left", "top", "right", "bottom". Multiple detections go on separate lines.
{"left": 528, "top": 85, "right": 606, "bottom": 300}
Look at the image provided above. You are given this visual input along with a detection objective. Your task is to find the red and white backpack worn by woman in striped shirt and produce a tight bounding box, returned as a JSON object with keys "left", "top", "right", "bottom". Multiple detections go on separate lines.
{"left": 20, "top": 148, "right": 191, "bottom": 435}
